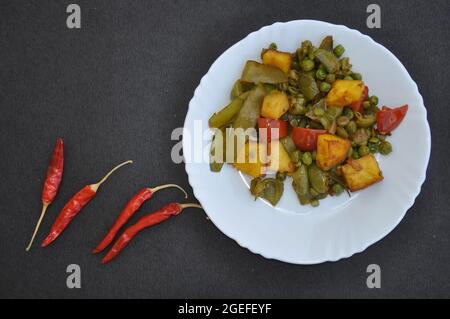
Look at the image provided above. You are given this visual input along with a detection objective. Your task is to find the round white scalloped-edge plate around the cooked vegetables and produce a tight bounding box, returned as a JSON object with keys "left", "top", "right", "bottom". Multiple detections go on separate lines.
{"left": 183, "top": 20, "right": 431, "bottom": 264}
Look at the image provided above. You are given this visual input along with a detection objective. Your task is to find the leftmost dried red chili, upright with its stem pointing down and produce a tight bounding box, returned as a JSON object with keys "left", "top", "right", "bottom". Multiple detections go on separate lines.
{"left": 25, "top": 138, "right": 64, "bottom": 251}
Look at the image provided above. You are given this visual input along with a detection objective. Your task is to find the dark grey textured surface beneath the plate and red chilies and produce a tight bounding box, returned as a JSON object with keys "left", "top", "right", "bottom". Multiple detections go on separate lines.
{"left": 0, "top": 0, "right": 450, "bottom": 298}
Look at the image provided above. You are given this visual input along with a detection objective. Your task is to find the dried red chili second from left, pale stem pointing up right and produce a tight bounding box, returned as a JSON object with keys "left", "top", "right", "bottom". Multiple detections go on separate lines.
{"left": 41, "top": 161, "right": 133, "bottom": 247}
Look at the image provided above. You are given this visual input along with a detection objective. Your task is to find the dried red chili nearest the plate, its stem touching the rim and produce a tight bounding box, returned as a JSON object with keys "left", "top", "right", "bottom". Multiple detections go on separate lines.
{"left": 102, "top": 203, "right": 202, "bottom": 264}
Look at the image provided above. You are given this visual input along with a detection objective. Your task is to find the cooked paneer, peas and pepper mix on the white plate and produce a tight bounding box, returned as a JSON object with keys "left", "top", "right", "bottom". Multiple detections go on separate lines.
{"left": 209, "top": 36, "right": 408, "bottom": 206}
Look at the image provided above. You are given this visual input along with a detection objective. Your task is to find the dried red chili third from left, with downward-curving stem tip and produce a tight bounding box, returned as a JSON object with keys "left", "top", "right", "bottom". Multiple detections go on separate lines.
{"left": 92, "top": 184, "right": 187, "bottom": 254}
